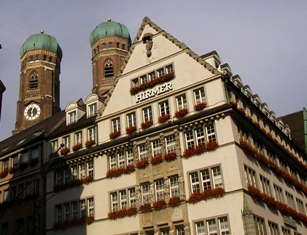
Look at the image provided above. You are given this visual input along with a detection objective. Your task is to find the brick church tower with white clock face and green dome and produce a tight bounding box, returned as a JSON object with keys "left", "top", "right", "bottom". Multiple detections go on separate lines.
{"left": 13, "top": 32, "right": 62, "bottom": 134}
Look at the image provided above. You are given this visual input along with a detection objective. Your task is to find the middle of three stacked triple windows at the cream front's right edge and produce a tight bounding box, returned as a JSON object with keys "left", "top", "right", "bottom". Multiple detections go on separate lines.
{"left": 189, "top": 166, "right": 223, "bottom": 193}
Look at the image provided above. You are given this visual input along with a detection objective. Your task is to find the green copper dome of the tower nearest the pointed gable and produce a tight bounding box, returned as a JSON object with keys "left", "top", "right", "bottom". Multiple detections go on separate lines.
{"left": 90, "top": 19, "right": 131, "bottom": 46}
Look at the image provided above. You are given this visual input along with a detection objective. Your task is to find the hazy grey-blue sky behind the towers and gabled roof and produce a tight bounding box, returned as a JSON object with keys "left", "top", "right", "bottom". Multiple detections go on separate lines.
{"left": 0, "top": 0, "right": 307, "bottom": 141}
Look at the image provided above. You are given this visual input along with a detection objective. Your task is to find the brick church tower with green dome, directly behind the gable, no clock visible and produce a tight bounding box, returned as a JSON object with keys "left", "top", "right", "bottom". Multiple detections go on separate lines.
{"left": 89, "top": 19, "right": 131, "bottom": 95}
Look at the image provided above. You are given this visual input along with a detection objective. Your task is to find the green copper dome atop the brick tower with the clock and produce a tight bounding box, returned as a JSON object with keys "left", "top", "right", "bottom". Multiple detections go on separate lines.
{"left": 20, "top": 32, "right": 63, "bottom": 59}
